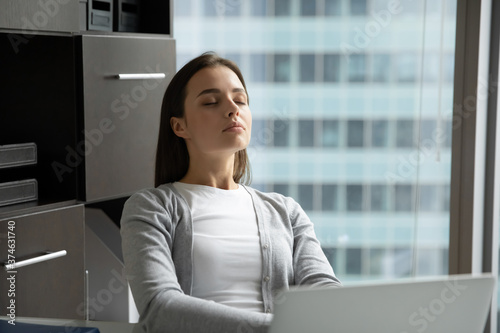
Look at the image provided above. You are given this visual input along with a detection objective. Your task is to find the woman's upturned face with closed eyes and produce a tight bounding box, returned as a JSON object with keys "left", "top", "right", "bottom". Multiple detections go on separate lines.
{"left": 171, "top": 66, "right": 252, "bottom": 156}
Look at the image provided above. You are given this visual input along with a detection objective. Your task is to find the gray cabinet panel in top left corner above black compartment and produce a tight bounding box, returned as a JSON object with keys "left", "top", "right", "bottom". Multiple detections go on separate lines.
{"left": 0, "top": 0, "right": 80, "bottom": 32}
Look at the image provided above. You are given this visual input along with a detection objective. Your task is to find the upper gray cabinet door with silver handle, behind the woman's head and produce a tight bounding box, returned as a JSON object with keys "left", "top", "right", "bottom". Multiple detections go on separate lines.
{"left": 80, "top": 35, "right": 175, "bottom": 201}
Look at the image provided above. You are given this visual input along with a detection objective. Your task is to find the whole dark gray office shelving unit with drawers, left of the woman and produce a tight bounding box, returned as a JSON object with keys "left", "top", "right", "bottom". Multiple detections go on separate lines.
{"left": 0, "top": 0, "right": 175, "bottom": 321}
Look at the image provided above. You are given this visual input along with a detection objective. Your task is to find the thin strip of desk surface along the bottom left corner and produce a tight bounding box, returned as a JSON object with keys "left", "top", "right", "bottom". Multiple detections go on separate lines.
{"left": 0, "top": 316, "right": 134, "bottom": 333}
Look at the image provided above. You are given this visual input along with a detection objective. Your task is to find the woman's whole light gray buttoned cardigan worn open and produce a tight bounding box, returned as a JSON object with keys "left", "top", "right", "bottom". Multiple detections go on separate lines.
{"left": 121, "top": 184, "right": 340, "bottom": 333}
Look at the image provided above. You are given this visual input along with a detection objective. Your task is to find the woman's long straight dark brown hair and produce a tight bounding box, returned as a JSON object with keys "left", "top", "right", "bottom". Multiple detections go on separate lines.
{"left": 155, "top": 52, "right": 251, "bottom": 186}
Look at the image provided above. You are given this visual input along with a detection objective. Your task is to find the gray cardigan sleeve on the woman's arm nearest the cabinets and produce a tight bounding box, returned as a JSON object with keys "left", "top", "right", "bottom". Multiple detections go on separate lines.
{"left": 121, "top": 190, "right": 272, "bottom": 333}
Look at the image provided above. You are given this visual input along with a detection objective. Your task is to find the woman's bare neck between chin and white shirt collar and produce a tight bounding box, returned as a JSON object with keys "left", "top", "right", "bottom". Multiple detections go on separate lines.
{"left": 180, "top": 154, "right": 238, "bottom": 190}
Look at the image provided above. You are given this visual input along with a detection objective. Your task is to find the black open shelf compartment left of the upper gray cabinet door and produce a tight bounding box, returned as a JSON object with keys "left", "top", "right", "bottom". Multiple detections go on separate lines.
{"left": 0, "top": 33, "right": 80, "bottom": 205}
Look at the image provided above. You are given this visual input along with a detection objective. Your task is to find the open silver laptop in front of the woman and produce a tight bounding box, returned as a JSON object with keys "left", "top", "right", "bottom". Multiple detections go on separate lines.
{"left": 269, "top": 274, "right": 496, "bottom": 333}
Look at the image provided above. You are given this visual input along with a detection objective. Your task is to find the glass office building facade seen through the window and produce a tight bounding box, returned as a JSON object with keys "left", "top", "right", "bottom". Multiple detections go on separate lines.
{"left": 174, "top": 0, "right": 456, "bottom": 284}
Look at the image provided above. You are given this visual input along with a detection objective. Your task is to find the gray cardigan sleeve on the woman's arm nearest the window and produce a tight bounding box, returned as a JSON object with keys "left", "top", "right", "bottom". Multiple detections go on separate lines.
{"left": 287, "top": 198, "right": 342, "bottom": 287}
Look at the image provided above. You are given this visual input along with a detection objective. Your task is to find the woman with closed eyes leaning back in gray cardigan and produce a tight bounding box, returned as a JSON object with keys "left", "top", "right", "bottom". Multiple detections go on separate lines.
{"left": 121, "top": 53, "right": 340, "bottom": 333}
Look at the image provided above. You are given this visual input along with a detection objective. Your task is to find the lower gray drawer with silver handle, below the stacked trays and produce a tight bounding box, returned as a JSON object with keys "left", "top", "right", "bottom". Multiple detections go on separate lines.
{"left": 0, "top": 205, "right": 85, "bottom": 319}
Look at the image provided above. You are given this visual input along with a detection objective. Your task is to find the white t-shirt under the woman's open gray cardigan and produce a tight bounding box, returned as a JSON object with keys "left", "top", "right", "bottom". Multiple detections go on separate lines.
{"left": 174, "top": 182, "right": 264, "bottom": 312}
